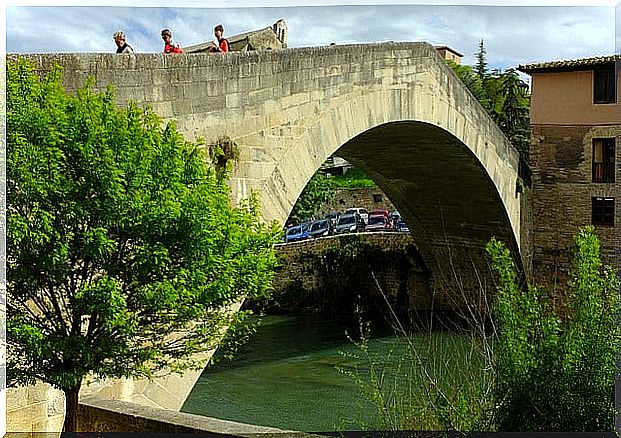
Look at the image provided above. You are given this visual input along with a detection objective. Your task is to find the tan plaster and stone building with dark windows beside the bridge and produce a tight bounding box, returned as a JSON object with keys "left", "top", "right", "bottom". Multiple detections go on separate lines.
{"left": 518, "top": 55, "right": 621, "bottom": 292}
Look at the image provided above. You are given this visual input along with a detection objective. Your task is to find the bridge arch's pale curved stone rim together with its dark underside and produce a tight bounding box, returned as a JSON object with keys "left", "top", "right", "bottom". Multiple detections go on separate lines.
{"left": 259, "top": 79, "right": 521, "bottom": 310}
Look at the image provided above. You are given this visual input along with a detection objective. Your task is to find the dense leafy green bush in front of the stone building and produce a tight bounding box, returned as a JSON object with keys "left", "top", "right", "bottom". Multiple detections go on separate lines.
{"left": 487, "top": 226, "right": 621, "bottom": 431}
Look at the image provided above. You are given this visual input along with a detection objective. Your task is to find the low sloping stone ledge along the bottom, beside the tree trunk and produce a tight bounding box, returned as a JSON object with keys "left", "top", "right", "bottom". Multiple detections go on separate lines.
{"left": 78, "top": 397, "right": 317, "bottom": 438}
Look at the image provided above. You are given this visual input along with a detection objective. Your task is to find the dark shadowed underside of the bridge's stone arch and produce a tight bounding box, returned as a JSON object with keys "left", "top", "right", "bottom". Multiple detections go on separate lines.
{"left": 268, "top": 116, "right": 521, "bottom": 313}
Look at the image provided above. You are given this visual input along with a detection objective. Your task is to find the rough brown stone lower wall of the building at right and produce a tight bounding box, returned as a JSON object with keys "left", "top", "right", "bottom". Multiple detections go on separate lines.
{"left": 531, "top": 125, "right": 621, "bottom": 294}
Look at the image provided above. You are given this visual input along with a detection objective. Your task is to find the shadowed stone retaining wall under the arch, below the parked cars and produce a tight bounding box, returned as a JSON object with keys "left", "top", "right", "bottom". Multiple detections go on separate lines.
{"left": 268, "top": 232, "right": 489, "bottom": 325}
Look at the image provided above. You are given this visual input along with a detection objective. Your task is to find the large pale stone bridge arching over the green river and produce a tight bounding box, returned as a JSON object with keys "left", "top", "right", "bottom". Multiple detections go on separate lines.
{"left": 14, "top": 43, "right": 529, "bottom": 420}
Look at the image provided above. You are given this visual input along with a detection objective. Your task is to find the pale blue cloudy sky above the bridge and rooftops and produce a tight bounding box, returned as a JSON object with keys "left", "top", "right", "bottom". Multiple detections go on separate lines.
{"left": 6, "top": 0, "right": 621, "bottom": 69}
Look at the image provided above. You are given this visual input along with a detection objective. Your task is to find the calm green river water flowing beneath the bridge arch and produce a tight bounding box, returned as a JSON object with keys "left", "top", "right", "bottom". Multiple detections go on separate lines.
{"left": 182, "top": 315, "right": 484, "bottom": 432}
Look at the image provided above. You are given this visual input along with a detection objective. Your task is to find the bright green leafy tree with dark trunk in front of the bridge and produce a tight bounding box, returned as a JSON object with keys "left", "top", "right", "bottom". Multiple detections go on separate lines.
{"left": 7, "top": 59, "right": 277, "bottom": 431}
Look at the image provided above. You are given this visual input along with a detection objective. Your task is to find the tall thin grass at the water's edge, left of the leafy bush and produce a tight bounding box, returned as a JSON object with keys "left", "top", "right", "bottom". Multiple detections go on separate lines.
{"left": 339, "top": 278, "right": 494, "bottom": 431}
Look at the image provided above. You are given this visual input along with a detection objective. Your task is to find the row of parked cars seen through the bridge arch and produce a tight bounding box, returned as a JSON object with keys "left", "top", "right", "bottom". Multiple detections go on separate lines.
{"left": 285, "top": 208, "right": 410, "bottom": 242}
